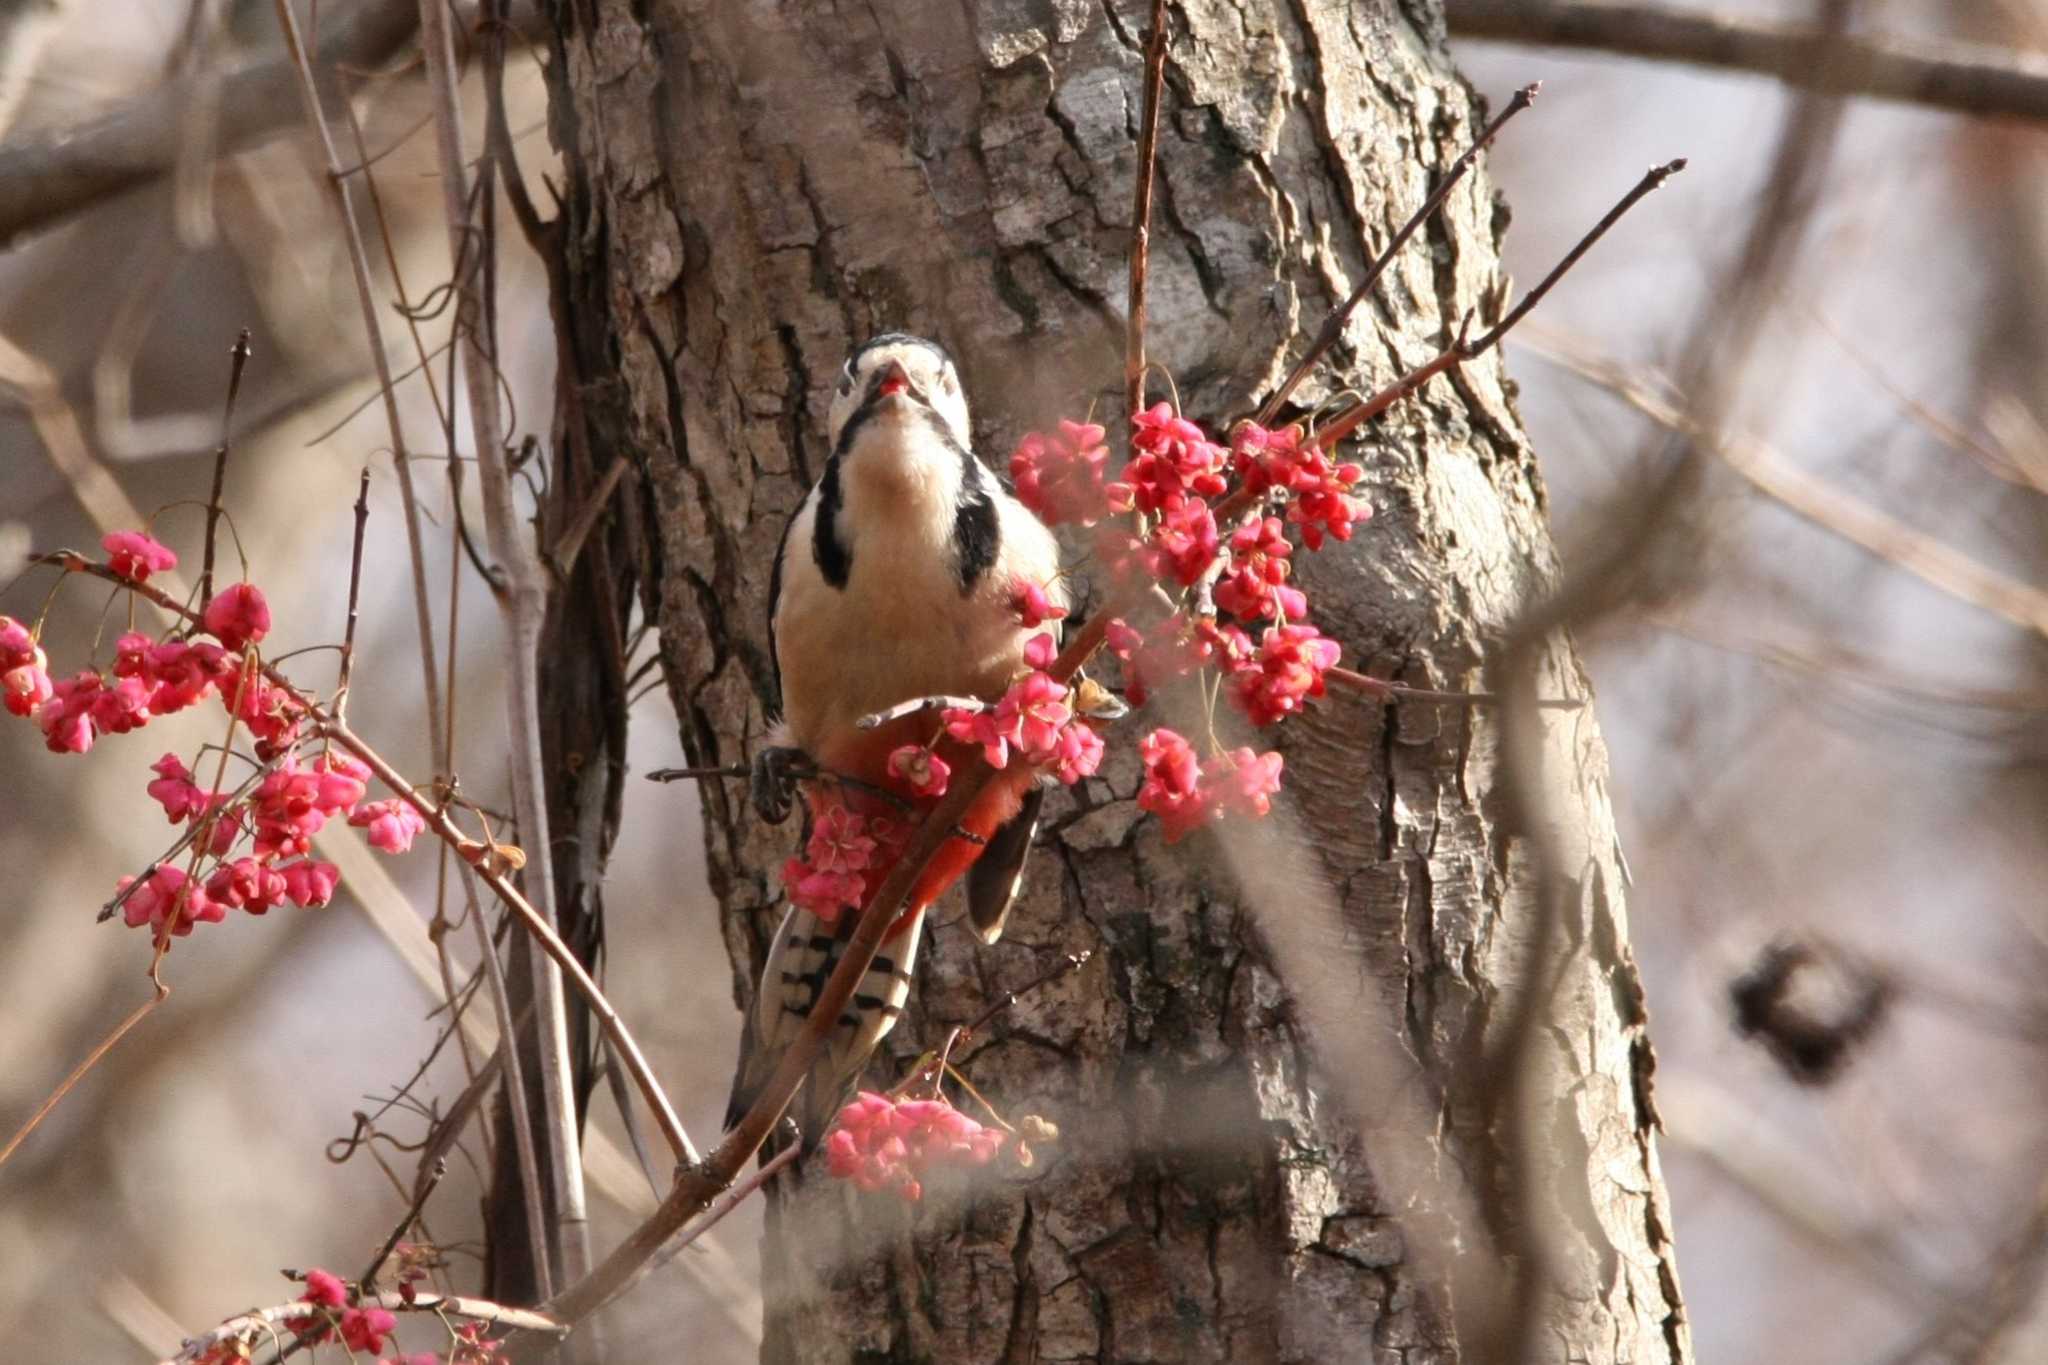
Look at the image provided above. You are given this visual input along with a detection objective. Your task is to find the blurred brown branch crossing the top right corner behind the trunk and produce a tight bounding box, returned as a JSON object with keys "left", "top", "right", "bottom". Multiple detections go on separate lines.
{"left": 1444, "top": 0, "right": 2048, "bottom": 119}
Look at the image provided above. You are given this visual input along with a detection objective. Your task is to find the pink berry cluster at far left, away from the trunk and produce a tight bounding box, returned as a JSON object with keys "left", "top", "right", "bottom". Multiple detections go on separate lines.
{"left": 0, "top": 532, "right": 426, "bottom": 941}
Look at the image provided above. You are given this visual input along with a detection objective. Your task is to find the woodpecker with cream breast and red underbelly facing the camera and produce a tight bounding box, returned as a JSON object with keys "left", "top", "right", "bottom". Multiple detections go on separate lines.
{"left": 727, "top": 332, "right": 1065, "bottom": 1148}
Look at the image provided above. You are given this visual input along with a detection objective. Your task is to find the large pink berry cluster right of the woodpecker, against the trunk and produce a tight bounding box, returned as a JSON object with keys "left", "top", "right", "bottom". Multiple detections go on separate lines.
{"left": 999, "top": 403, "right": 1372, "bottom": 841}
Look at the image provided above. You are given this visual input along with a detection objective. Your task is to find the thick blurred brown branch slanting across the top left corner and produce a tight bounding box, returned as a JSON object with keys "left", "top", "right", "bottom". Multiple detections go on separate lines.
{"left": 0, "top": 0, "right": 414, "bottom": 248}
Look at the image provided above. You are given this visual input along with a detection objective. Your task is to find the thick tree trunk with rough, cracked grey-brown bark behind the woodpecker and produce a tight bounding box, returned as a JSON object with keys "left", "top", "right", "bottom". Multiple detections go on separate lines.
{"left": 549, "top": 0, "right": 1690, "bottom": 1361}
